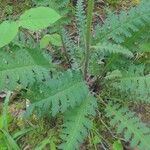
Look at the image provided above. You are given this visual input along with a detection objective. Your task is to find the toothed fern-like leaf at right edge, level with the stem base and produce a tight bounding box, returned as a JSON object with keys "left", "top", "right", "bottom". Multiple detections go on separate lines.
{"left": 112, "top": 65, "right": 150, "bottom": 102}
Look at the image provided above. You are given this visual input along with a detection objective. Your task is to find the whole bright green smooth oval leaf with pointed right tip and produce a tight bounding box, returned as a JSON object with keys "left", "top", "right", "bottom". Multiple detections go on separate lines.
{"left": 19, "top": 7, "right": 61, "bottom": 31}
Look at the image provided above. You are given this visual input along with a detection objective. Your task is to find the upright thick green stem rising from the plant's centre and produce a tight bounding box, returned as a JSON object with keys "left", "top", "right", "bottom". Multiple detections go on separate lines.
{"left": 84, "top": 0, "right": 94, "bottom": 79}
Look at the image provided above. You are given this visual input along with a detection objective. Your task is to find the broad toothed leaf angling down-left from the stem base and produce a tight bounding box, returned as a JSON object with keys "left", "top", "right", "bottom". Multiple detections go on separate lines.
{"left": 23, "top": 71, "right": 89, "bottom": 116}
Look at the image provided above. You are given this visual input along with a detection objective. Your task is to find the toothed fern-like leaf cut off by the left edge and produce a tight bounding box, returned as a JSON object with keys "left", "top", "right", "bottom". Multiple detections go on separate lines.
{"left": 0, "top": 47, "right": 52, "bottom": 90}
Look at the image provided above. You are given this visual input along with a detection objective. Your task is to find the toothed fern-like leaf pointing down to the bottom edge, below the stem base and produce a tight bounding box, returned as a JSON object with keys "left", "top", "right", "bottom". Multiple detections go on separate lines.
{"left": 60, "top": 96, "right": 97, "bottom": 150}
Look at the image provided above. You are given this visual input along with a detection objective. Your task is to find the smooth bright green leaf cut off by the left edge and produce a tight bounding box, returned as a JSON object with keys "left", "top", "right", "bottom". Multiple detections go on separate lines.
{"left": 0, "top": 21, "right": 19, "bottom": 48}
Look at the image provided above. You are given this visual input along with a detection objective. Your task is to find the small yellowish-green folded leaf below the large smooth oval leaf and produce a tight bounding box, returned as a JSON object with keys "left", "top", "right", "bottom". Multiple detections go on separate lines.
{"left": 40, "top": 34, "right": 62, "bottom": 48}
